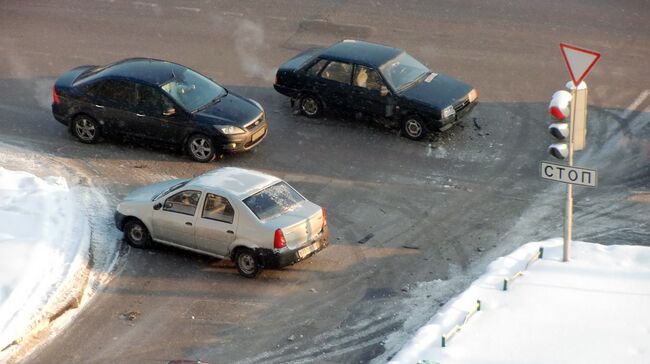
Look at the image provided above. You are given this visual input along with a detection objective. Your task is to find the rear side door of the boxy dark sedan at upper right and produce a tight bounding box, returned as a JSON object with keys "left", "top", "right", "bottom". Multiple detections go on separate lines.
{"left": 314, "top": 61, "right": 352, "bottom": 108}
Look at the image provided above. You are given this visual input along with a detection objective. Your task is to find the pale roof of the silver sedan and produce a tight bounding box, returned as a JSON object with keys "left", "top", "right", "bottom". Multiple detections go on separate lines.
{"left": 185, "top": 167, "right": 282, "bottom": 199}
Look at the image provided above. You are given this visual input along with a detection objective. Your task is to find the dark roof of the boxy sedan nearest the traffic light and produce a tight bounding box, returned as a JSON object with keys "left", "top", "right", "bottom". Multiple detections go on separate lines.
{"left": 321, "top": 39, "right": 404, "bottom": 68}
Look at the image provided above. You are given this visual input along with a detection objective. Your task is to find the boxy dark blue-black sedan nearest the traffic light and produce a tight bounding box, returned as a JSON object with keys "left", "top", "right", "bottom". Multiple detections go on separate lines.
{"left": 274, "top": 40, "right": 478, "bottom": 140}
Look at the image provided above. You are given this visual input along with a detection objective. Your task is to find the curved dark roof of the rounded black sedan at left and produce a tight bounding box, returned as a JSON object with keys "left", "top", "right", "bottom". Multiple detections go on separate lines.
{"left": 83, "top": 58, "right": 187, "bottom": 85}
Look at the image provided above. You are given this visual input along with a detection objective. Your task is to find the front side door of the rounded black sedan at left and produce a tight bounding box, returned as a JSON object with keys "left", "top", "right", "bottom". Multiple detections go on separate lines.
{"left": 135, "top": 84, "right": 189, "bottom": 144}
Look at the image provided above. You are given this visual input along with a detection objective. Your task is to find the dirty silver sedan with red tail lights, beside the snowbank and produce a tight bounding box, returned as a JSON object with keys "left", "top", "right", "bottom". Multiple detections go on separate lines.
{"left": 115, "top": 167, "right": 329, "bottom": 277}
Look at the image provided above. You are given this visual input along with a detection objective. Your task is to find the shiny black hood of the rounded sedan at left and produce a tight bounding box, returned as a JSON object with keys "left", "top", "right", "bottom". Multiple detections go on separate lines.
{"left": 196, "top": 92, "right": 263, "bottom": 126}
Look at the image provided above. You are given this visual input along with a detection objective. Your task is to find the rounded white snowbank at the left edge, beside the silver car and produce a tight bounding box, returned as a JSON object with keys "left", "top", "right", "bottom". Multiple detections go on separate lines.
{"left": 0, "top": 167, "right": 90, "bottom": 354}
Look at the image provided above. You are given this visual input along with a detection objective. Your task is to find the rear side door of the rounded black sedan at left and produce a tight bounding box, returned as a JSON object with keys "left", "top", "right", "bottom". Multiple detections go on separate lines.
{"left": 88, "top": 79, "right": 137, "bottom": 134}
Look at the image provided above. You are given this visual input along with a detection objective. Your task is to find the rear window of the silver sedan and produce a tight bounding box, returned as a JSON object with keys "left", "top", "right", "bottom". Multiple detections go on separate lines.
{"left": 244, "top": 182, "right": 305, "bottom": 220}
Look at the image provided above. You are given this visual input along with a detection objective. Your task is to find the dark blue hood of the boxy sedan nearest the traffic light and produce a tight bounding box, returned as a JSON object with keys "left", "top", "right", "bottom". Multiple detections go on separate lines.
{"left": 401, "top": 74, "right": 472, "bottom": 109}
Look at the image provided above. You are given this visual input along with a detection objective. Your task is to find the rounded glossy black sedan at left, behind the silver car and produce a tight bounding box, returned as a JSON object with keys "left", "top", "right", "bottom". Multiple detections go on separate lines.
{"left": 52, "top": 58, "right": 268, "bottom": 162}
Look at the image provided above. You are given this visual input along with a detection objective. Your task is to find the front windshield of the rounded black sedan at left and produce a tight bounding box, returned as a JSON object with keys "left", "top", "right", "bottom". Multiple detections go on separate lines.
{"left": 161, "top": 68, "right": 226, "bottom": 111}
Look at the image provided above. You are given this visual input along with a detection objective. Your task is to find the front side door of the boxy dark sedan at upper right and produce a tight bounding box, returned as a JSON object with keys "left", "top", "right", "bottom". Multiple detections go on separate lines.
{"left": 351, "top": 65, "right": 394, "bottom": 117}
